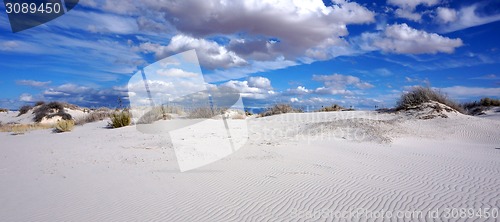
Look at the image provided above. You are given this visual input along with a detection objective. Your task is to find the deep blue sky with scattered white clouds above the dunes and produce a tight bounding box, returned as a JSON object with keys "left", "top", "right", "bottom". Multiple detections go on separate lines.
{"left": 0, "top": 0, "right": 500, "bottom": 109}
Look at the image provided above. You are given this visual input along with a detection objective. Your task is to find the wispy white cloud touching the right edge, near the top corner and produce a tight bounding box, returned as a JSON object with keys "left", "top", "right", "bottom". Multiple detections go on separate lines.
{"left": 436, "top": 3, "right": 500, "bottom": 33}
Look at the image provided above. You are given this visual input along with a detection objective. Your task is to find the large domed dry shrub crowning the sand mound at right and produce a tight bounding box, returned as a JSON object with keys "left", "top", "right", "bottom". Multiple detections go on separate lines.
{"left": 396, "top": 86, "right": 465, "bottom": 113}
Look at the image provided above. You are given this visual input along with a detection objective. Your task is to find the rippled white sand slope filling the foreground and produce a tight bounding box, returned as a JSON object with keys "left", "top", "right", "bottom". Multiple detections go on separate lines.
{"left": 0, "top": 111, "right": 500, "bottom": 221}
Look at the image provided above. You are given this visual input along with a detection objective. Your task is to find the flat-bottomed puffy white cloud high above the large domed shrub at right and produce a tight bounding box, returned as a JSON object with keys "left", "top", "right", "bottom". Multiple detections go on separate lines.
{"left": 360, "top": 23, "right": 463, "bottom": 54}
